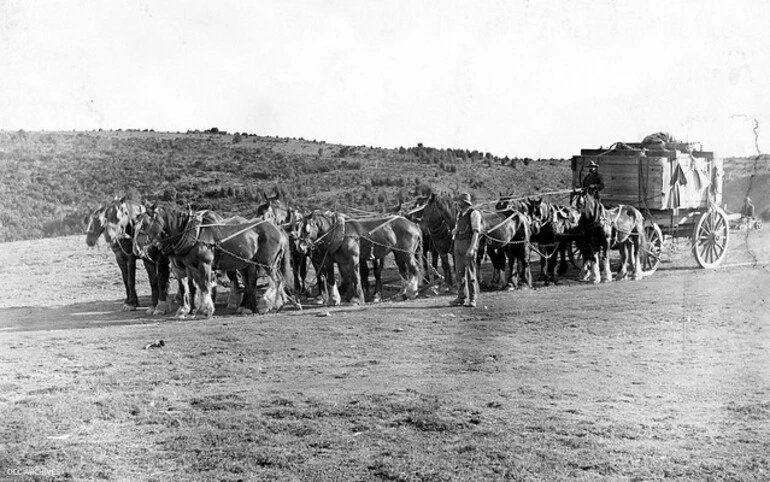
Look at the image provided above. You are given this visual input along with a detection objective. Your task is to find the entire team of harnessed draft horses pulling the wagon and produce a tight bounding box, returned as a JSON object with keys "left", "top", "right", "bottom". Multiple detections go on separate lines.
{"left": 86, "top": 190, "right": 646, "bottom": 318}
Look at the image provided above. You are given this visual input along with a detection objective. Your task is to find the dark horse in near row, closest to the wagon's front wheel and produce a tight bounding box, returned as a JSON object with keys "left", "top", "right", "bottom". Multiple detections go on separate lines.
{"left": 572, "top": 189, "right": 648, "bottom": 283}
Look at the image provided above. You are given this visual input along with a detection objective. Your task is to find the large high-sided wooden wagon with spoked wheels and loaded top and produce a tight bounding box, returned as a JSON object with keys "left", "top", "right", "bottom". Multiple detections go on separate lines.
{"left": 572, "top": 133, "right": 730, "bottom": 274}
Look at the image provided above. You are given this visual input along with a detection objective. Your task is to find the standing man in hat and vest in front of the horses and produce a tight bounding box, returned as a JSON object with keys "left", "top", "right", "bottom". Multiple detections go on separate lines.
{"left": 449, "top": 192, "right": 481, "bottom": 308}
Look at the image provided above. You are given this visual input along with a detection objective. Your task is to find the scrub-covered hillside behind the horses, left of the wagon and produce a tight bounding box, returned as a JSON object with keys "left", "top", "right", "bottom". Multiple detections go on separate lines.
{"left": 0, "top": 129, "right": 570, "bottom": 241}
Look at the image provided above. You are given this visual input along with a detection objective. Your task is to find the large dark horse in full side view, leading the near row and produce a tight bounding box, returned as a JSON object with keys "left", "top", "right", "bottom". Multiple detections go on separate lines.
{"left": 135, "top": 208, "right": 292, "bottom": 317}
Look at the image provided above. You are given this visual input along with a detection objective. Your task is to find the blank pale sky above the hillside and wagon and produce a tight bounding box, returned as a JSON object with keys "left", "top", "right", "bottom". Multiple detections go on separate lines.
{"left": 0, "top": 0, "right": 770, "bottom": 157}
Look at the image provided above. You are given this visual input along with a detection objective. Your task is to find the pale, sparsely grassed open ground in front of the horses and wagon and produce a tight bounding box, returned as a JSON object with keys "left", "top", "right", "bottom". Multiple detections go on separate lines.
{"left": 0, "top": 234, "right": 770, "bottom": 481}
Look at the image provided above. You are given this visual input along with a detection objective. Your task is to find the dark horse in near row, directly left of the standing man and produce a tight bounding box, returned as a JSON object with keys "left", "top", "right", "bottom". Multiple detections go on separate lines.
{"left": 299, "top": 212, "right": 422, "bottom": 304}
